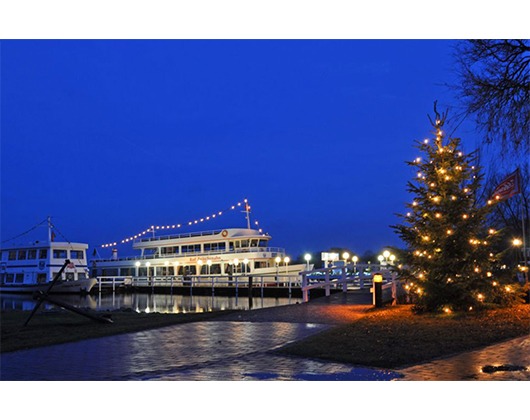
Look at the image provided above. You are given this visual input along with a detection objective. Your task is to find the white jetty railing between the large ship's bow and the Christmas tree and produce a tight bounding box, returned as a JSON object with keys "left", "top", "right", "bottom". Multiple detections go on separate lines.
{"left": 300, "top": 264, "right": 397, "bottom": 302}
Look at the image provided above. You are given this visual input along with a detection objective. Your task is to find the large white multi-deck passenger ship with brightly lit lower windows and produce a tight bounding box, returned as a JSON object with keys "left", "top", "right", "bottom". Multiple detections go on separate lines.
{"left": 92, "top": 228, "right": 306, "bottom": 279}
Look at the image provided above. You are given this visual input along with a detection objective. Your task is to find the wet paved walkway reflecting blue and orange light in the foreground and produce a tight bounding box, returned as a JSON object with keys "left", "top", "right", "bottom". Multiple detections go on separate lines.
{"left": 0, "top": 293, "right": 530, "bottom": 381}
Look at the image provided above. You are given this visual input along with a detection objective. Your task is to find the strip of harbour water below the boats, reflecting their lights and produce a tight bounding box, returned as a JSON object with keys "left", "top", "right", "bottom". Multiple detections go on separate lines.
{"left": 0, "top": 293, "right": 302, "bottom": 313}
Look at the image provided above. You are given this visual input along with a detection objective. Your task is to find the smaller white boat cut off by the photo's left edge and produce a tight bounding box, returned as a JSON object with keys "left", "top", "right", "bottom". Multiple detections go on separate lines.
{"left": 0, "top": 218, "right": 97, "bottom": 293}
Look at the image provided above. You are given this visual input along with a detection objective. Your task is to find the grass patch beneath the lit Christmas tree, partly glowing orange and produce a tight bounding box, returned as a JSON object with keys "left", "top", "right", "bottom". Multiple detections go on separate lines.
{"left": 281, "top": 304, "right": 530, "bottom": 368}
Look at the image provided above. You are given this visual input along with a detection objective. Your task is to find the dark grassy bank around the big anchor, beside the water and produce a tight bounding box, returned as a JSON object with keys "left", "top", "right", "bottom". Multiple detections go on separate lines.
{"left": 0, "top": 310, "right": 231, "bottom": 352}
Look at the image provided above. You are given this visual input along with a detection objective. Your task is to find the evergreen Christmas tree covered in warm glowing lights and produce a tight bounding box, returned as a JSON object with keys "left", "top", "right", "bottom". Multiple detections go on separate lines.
{"left": 392, "top": 107, "right": 513, "bottom": 312}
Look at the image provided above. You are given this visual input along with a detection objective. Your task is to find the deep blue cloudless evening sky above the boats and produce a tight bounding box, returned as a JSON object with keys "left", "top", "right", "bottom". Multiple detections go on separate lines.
{"left": 0, "top": 40, "right": 477, "bottom": 257}
